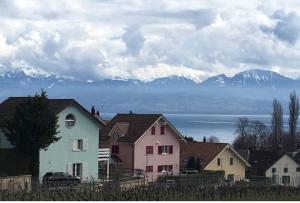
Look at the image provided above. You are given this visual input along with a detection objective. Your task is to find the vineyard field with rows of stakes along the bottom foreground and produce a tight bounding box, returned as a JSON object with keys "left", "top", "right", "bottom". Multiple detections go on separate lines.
{"left": 0, "top": 184, "right": 300, "bottom": 201}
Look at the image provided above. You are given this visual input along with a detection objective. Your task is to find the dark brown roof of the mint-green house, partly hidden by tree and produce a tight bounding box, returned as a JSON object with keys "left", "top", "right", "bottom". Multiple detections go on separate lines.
{"left": 0, "top": 97, "right": 105, "bottom": 126}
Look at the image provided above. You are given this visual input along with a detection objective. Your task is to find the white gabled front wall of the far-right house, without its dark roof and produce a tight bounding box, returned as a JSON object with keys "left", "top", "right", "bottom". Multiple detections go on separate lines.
{"left": 266, "top": 154, "right": 300, "bottom": 186}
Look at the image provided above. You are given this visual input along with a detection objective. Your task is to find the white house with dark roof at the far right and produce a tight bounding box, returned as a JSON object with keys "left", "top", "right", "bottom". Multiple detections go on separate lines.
{"left": 249, "top": 150, "right": 300, "bottom": 186}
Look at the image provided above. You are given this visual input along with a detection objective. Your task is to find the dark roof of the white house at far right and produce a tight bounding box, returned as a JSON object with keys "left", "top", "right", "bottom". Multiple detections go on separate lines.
{"left": 248, "top": 150, "right": 284, "bottom": 176}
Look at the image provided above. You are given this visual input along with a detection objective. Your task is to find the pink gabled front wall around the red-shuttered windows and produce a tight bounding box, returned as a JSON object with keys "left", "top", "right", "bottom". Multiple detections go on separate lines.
{"left": 134, "top": 120, "right": 180, "bottom": 181}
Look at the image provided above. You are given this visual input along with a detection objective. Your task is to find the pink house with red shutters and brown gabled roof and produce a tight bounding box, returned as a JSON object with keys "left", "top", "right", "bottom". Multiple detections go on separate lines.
{"left": 100, "top": 113, "right": 185, "bottom": 181}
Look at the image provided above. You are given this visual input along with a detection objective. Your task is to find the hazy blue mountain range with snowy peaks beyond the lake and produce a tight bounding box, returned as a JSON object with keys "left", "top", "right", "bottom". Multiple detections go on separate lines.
{"left": 0, "top": 69, "right": 300, "bottom": 114}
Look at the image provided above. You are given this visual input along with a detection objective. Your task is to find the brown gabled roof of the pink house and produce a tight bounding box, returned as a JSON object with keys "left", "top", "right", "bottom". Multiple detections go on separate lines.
{"left": 99, "top": 113, "right": 183, "bottom": 143}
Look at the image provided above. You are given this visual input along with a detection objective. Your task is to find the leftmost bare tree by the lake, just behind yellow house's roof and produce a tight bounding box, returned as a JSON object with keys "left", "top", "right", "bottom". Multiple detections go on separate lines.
{"left": 233, "top": 117, "right": 249, "bottom": 149}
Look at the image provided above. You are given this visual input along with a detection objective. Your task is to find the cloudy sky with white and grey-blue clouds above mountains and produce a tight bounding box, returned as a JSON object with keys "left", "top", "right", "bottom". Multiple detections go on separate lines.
{"left": 0, "top": 0, "right": 300, "bottom": 81}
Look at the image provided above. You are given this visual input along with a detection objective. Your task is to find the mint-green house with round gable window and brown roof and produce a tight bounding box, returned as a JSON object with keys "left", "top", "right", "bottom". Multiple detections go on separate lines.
{"left": 0, "top": 97, "right": 105, "bottom": 180}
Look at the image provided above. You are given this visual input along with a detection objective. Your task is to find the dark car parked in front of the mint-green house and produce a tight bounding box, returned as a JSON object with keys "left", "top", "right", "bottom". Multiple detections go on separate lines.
{"left": 43, "top": 172, "right": 81, "bottom": 186}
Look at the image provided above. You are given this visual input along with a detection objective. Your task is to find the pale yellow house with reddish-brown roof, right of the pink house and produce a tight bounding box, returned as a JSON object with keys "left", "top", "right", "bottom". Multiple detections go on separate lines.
{"left": 180, "top": 142, "right": 250, "bottom": 181}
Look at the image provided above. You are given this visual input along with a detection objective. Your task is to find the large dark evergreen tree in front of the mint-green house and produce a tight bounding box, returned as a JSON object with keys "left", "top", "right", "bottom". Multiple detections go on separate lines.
{"left": 4, "top": 90, "right": 60, "bottom": 177}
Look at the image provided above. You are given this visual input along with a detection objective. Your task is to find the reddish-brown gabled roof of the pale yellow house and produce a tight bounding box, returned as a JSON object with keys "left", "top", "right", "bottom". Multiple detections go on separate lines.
{"left": 180, "top": 142, "right": 250, "bottom": 169}
